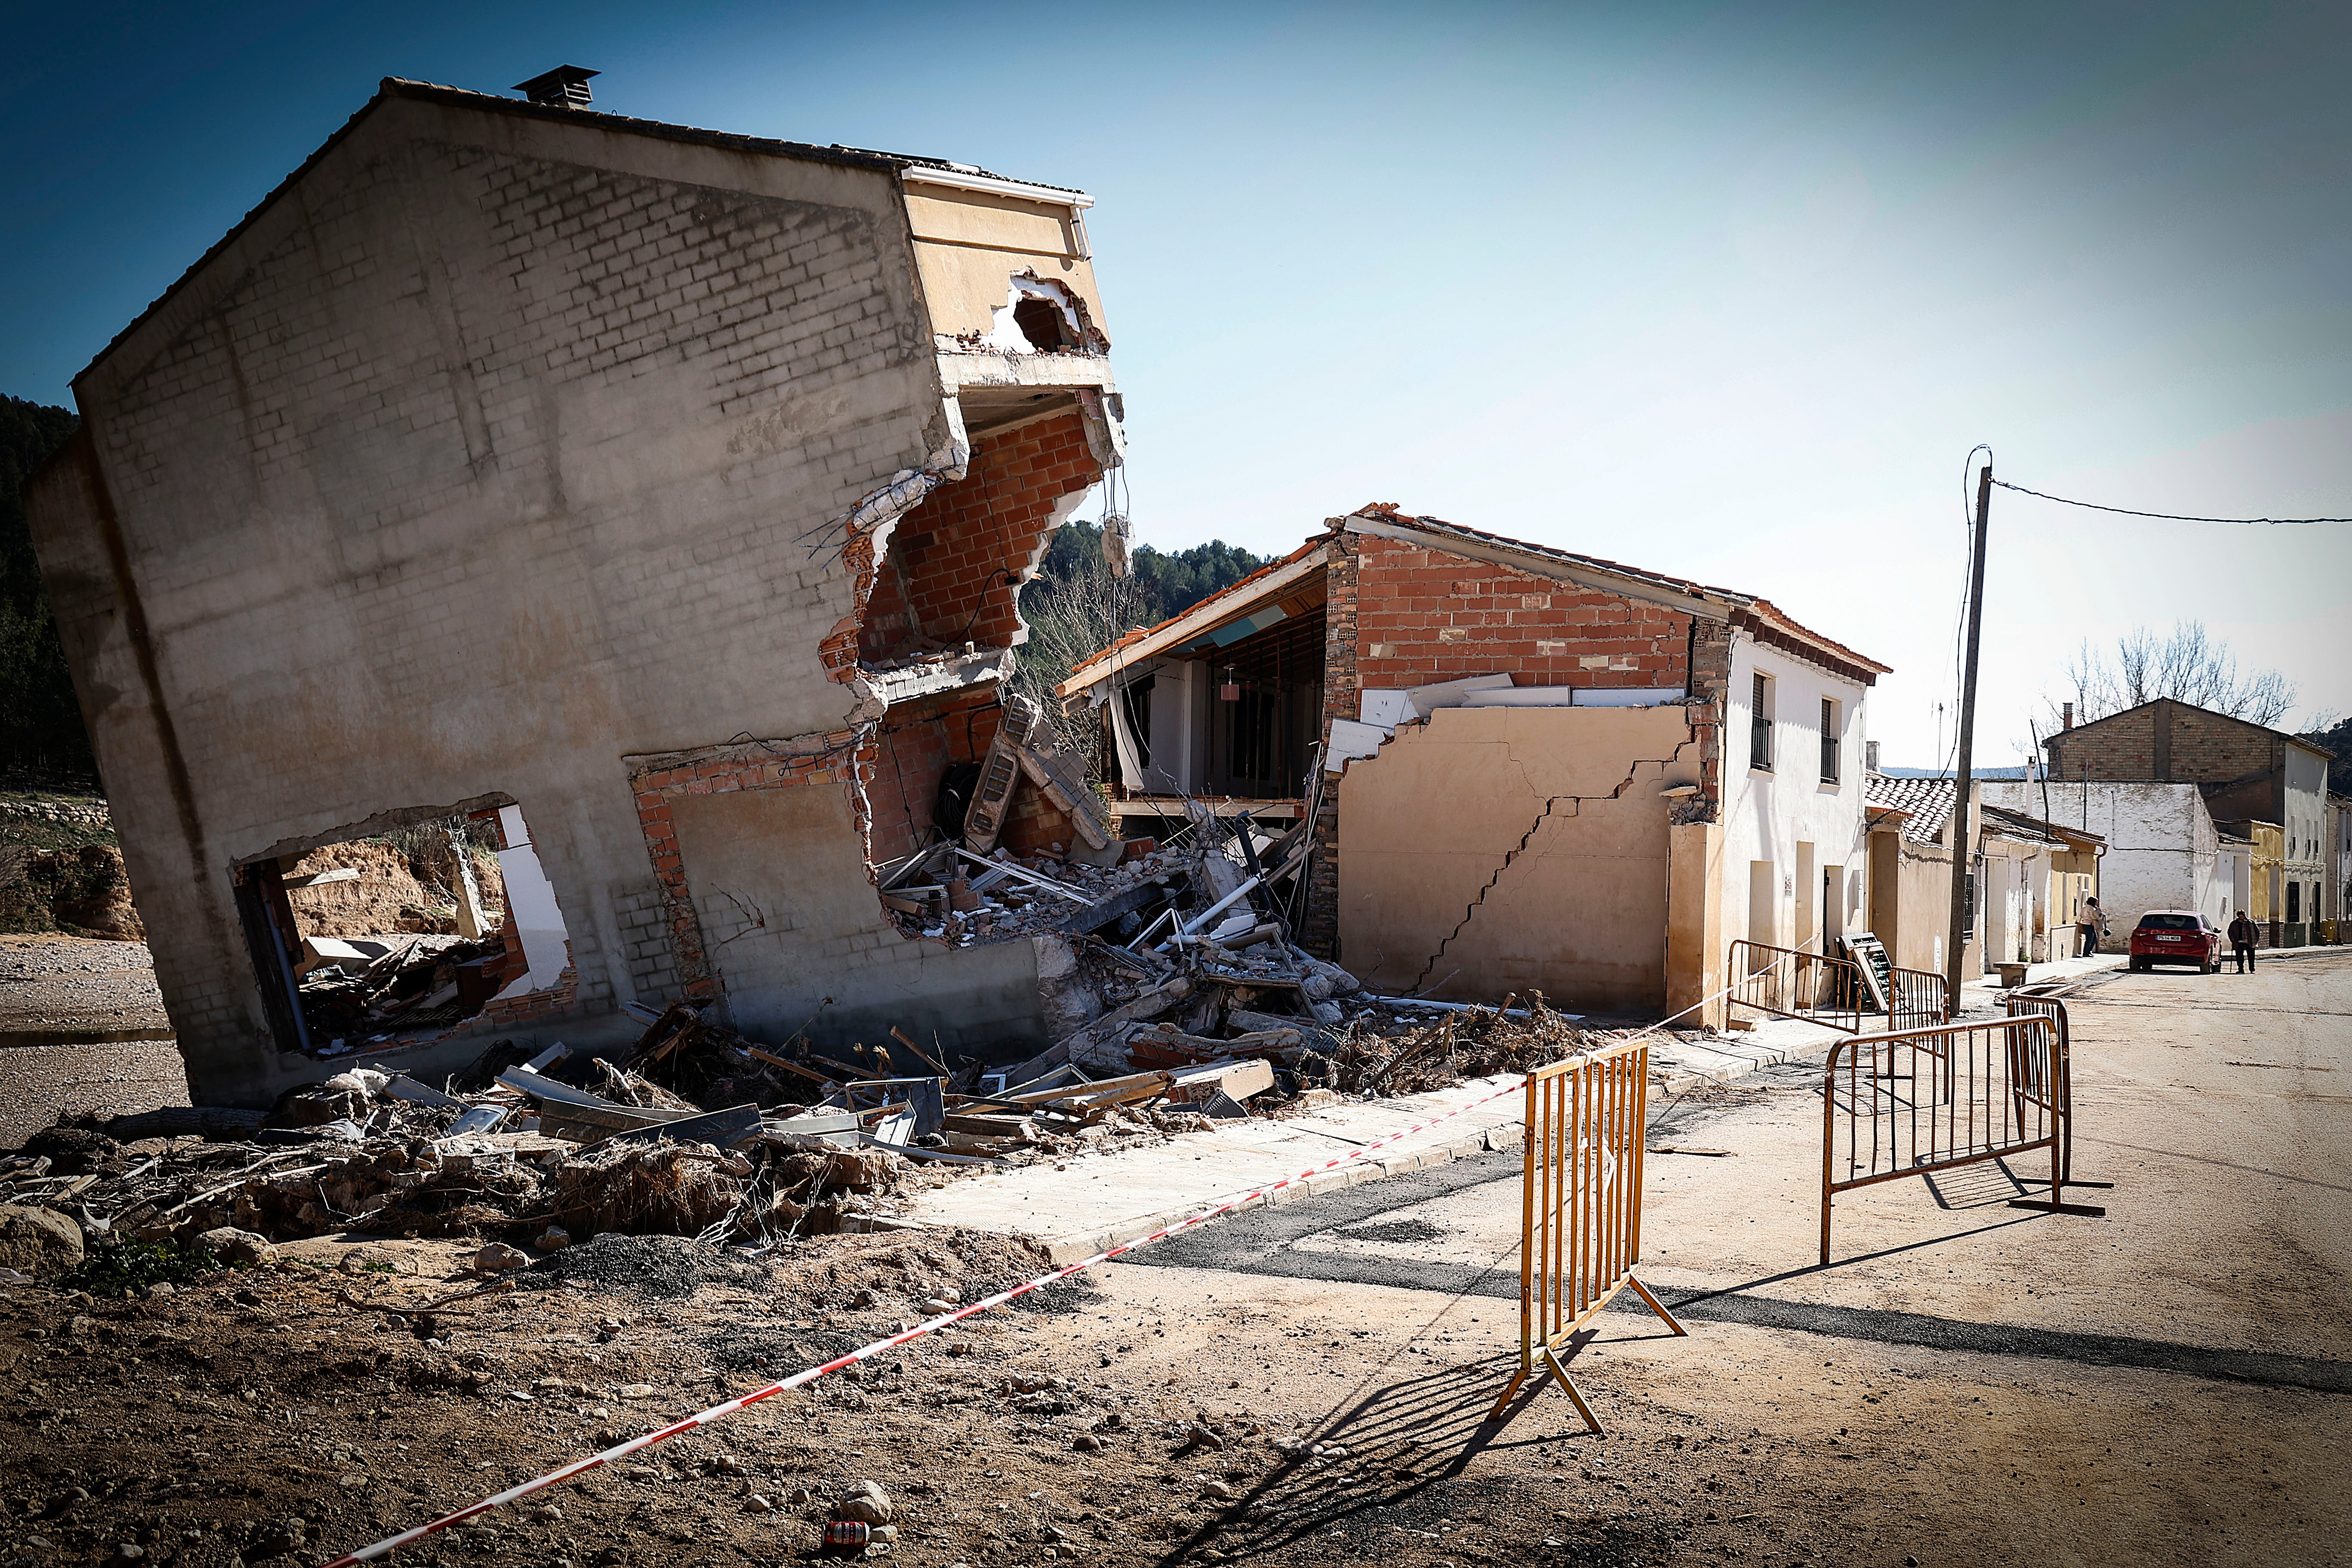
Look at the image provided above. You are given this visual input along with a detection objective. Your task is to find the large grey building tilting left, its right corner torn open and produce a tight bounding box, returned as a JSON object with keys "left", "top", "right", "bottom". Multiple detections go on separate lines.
{"left": 28, "top": 68, "right": 1122, "bottom": 1105}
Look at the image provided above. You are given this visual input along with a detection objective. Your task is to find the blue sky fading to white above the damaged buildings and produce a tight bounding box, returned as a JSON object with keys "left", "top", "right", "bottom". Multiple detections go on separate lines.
{"left": 0, "top": 2, "right": 2352, "bottom": 764}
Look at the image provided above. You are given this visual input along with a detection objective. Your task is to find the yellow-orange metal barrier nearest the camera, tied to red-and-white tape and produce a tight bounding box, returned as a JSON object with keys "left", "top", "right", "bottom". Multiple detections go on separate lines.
{"left": 1489, "top": 1044, "right": 1686, "bottom": 1432}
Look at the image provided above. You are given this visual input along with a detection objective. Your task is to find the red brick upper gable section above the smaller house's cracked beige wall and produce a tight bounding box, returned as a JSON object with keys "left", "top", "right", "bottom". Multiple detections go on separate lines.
{"left": 1350, "top": 536, "right": 1691, "bottom": 691}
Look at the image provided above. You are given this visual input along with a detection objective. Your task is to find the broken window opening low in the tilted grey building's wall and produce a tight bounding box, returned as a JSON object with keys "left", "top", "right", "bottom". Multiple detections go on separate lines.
{"left": 230, "top": 806, "right": 572, "bottom": 1056}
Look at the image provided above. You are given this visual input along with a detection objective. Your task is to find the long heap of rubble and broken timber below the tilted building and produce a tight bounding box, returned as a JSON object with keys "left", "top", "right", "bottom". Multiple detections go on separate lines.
{"left": 0, "top": 818, "right": 1592, "bottom": 1274}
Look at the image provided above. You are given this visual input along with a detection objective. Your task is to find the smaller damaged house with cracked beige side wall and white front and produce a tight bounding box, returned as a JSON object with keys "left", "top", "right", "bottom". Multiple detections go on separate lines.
{"left": 1061, "top": 505, "right": 1886, "bottom": 1025}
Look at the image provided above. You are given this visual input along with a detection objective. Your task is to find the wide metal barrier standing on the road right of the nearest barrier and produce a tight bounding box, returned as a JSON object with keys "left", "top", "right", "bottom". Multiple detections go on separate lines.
{"left": 1820, "top": 1020, "right": 2107, "bottom": 1262}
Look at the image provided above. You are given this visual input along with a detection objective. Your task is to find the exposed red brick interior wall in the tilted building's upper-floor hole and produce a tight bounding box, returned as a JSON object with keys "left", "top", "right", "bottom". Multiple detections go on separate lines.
{"left": 889, "top": 409, "right": 1103, "bottom": 649}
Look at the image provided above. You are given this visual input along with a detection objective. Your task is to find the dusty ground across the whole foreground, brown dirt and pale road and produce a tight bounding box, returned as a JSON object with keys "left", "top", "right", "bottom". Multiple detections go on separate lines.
{"left": 0, "top": 959, "right": 2352, "bottom": 1568}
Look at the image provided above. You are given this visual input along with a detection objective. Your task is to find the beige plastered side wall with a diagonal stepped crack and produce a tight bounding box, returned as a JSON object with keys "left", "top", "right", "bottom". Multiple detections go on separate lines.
{"left": 1338, "top": 707, "right": 1705, "bottom": 1006}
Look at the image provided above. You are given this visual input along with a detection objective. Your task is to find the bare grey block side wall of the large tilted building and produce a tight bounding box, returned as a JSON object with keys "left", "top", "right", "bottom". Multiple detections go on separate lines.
{"left": 33, "top": 96, "right": 1039, "bottom": 1102}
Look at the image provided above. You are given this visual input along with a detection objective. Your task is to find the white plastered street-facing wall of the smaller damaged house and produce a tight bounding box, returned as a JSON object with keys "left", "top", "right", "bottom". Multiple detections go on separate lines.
{"left": 1717, "top": 630, "right": 1870, "bottom": 950}
